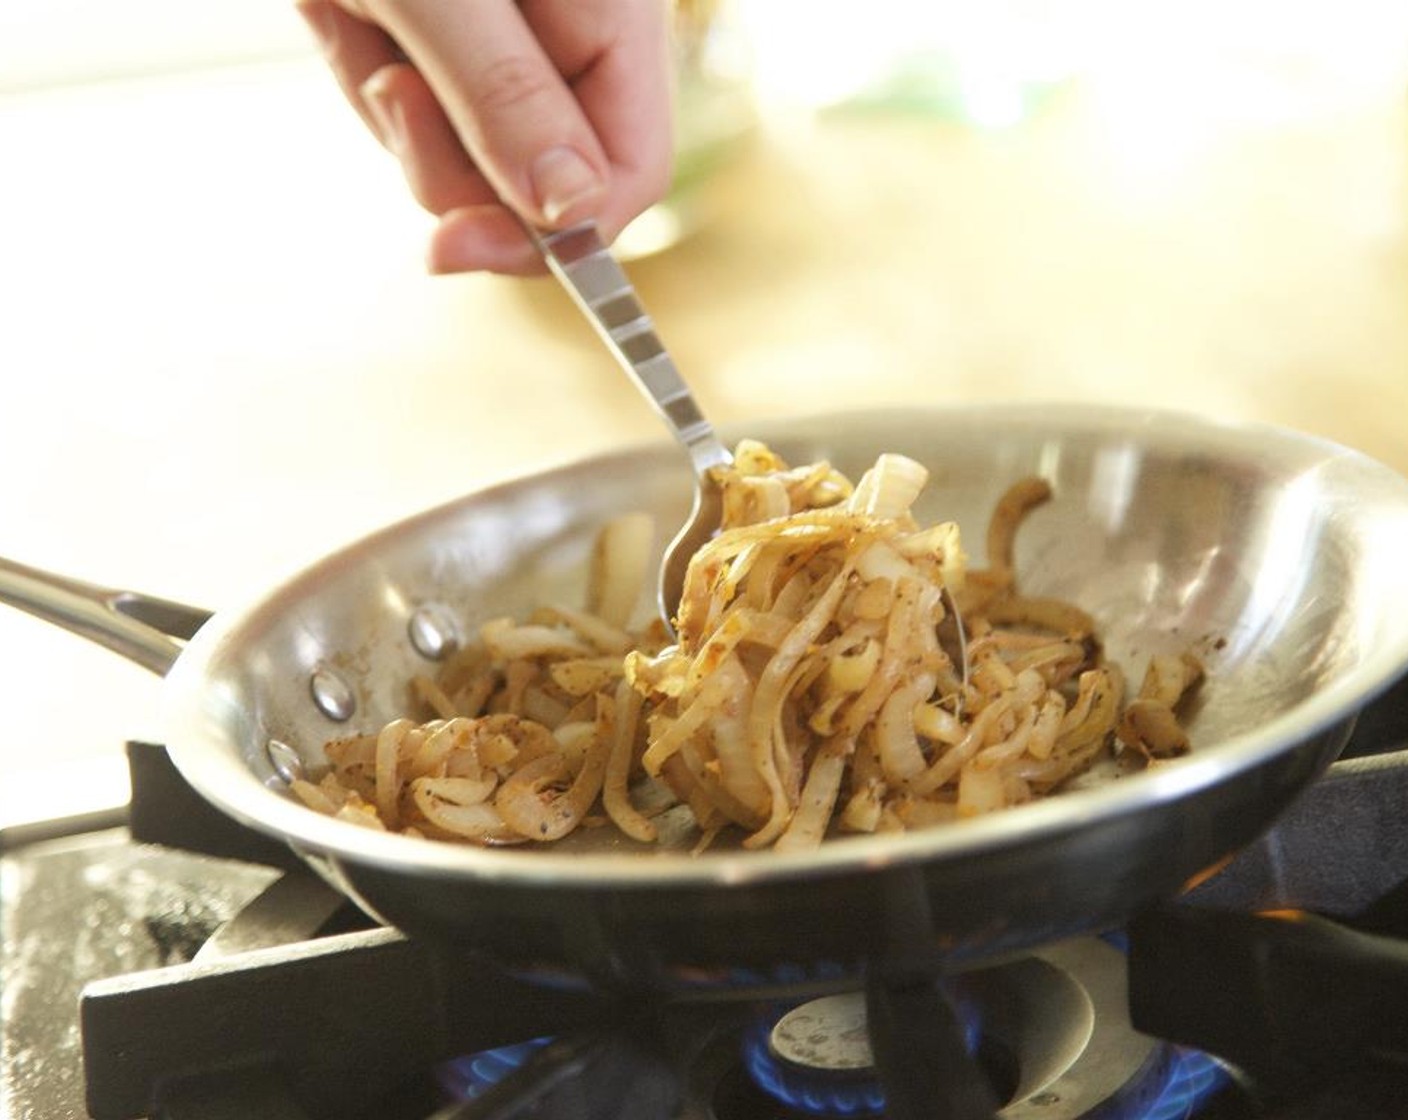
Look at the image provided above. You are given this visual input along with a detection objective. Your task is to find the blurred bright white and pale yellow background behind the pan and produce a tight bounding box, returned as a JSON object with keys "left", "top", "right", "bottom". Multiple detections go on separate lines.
{"left": 0, "top": 0, "right": 1408, "bottom": 824}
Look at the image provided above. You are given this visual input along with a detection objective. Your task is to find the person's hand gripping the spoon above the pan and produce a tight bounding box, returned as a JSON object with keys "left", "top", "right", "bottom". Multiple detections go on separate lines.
{"left": 296, "top": 0, "right": 672, "bottom": 273}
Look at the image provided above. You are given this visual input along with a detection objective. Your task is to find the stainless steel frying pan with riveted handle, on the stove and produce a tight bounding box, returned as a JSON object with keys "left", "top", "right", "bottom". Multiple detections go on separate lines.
{"left": 8, "top": 406, "right": 1408, "bottom": 990}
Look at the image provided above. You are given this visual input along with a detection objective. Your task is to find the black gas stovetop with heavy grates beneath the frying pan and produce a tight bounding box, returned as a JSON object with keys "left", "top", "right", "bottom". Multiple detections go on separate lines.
{"left": 11, "top": 718, "right": 1408, "bottom": 1120}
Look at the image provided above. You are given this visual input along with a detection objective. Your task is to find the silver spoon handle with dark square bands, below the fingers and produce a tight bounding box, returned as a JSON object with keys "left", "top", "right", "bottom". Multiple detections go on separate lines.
{"left": 528, "top": 221, "right": 732, "bottom": 476}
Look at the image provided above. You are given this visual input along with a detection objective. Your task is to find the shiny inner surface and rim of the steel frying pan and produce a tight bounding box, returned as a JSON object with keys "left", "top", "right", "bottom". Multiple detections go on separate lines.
{"left": 166, "top": 406, "right": 1408, "bottom": 885}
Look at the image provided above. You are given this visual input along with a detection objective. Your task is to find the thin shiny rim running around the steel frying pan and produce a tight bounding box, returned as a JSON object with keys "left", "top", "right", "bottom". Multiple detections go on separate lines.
{"left": 162, "top": 402, "right": 1408, "bottom": 890}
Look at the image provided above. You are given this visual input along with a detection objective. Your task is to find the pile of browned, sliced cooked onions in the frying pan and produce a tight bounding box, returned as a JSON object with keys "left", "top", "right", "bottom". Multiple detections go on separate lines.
{"left": 294, "top": 441, "right": 1201, "bottom": 848}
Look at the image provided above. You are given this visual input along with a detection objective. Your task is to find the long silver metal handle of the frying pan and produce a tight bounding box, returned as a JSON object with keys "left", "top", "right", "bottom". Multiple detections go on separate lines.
{"left": 0, "top": 556, "right": 210, "bottom": 676}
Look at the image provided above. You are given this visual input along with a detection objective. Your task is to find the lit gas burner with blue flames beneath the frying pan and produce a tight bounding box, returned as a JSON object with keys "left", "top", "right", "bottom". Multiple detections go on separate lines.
{"left": 441, "top": 938, "right": 1228, "bottom": 1120}
